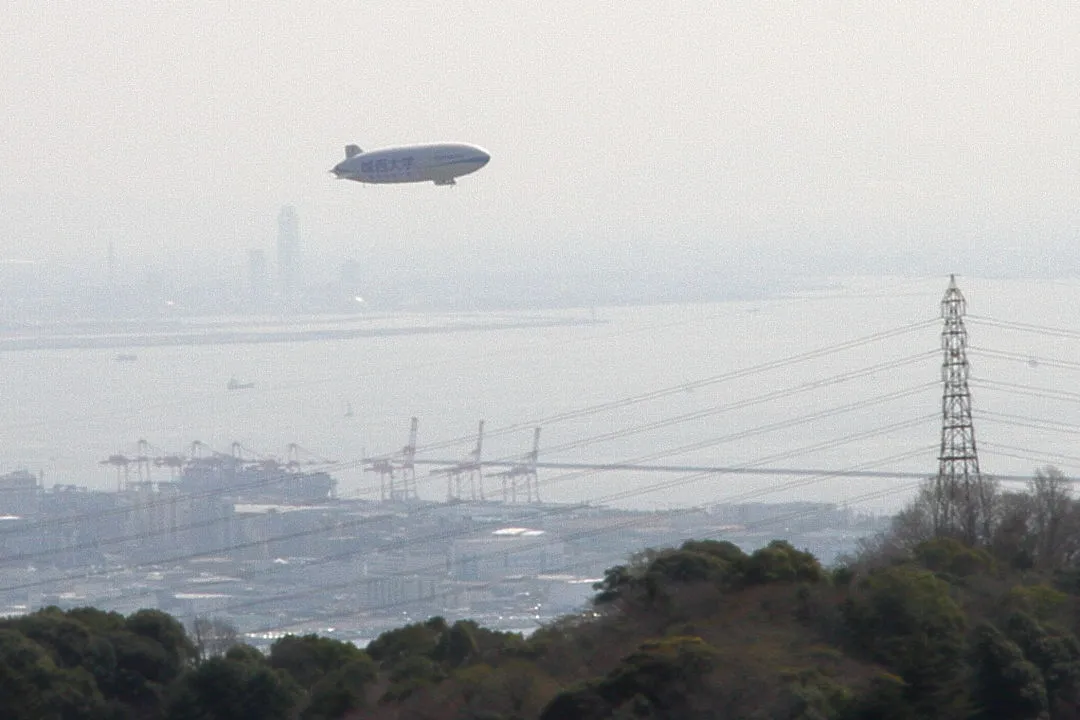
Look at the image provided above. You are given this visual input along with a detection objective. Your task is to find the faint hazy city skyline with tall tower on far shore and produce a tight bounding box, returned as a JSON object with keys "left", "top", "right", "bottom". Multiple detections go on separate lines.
{"left": 6, "top": 225, "right": 1080, "bottom": 322}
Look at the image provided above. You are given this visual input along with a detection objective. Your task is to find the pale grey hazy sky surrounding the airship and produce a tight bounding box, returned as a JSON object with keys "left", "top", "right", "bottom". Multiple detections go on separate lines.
{"left": 0, "top": 0, "right": 1080, "bottom": 280}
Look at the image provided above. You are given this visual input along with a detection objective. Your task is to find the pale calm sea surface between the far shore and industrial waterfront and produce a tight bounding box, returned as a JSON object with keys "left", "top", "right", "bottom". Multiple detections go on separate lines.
{"left": 0, "top": 279, "right": 1080, "bottom": 508}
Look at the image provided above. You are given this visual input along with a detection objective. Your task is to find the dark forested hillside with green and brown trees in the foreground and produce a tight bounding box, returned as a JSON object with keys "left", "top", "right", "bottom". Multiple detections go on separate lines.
{"left": 0, "top": 471, "right": 1080, "bottom": 720}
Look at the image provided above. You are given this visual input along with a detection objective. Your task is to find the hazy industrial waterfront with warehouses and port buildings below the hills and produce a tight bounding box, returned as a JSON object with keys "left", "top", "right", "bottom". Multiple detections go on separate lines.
{"left": 0, "top": 455, "right": 883, "bottom": 644}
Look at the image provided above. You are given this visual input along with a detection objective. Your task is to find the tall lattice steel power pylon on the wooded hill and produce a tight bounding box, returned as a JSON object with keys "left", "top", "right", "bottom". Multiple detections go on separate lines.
{"left": 935, "top": 275, "right": 981, "bottom": 540}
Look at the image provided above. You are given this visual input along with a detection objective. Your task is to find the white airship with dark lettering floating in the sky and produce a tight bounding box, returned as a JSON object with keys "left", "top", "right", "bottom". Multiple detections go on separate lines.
{"left": 330, "top": 142, "right": 491, "bottom": 185}
